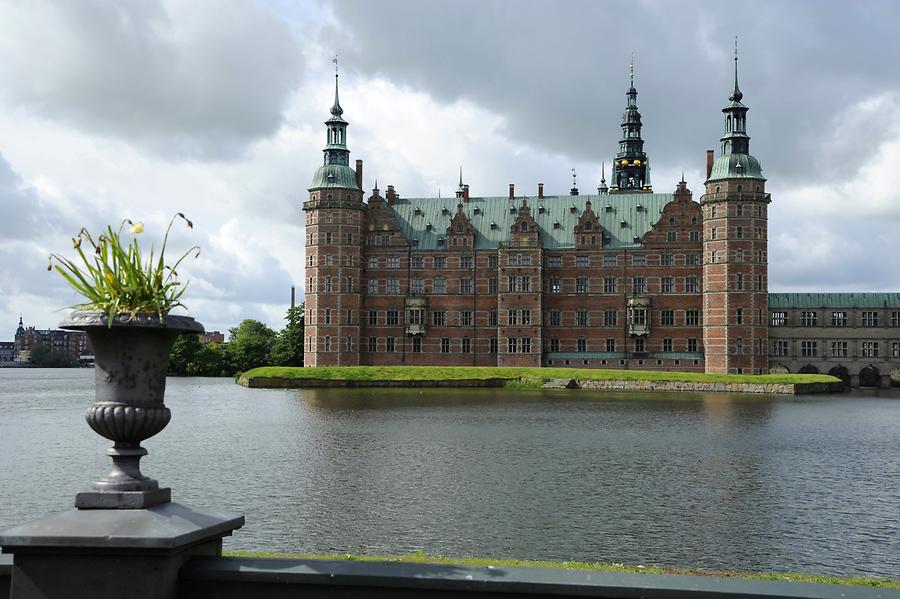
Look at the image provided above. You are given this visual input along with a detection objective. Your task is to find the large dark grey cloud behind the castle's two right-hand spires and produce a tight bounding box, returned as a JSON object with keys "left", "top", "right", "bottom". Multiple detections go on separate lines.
{"left": 321, "top": 0, "right": 900, "bottom": 189}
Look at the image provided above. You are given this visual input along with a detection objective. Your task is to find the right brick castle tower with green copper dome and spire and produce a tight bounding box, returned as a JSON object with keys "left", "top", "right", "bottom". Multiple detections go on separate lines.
{"left": 700, "top": 44, "right": 771, "bottom": 374}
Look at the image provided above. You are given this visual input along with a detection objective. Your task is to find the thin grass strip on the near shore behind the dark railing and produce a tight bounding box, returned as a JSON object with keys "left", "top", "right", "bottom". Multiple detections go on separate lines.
{"left": 225, "top": 551, "right": 900, "bottom": 589}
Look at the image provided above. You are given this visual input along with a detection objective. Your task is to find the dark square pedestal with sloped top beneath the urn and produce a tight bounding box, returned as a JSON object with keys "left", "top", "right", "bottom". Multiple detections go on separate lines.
{"left": 0, "top": 503, "right": 244, "bottom": 599}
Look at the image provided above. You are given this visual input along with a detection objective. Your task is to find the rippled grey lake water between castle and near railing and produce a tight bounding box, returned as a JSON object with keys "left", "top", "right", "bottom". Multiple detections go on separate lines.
{"left": 0, "top": 369, "right": 900, "bottom": 577}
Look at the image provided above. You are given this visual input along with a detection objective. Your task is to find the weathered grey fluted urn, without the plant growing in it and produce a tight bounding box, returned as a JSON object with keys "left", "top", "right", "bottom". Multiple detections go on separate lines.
{"left": 60, "top": 311, "right": 203, "bottom": 509}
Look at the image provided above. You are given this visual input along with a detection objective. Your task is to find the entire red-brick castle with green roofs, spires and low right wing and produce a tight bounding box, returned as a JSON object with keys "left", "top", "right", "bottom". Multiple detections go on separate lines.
{"left": 303, "top": 59, "right": 900, "bottom": 386}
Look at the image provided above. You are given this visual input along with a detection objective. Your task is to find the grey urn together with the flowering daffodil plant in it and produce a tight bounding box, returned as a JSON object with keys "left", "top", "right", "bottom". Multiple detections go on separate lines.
{"left": 47, "top": 213, "right": 203, "bottom": 509}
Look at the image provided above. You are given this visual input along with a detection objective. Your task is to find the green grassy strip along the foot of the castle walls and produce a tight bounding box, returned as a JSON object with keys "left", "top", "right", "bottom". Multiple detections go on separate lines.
{"left": 241, "top": 366, "right": 839, "bottom": 387}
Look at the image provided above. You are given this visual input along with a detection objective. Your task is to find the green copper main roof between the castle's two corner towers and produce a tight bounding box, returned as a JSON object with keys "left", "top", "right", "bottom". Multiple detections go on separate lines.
{"left": 391, "top": 193, "right": 673, "bottom": 250}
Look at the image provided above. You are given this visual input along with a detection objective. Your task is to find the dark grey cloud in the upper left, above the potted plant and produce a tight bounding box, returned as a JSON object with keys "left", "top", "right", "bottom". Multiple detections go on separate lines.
{"left": 0, "top": 0, "right": 302, "bottom": 158}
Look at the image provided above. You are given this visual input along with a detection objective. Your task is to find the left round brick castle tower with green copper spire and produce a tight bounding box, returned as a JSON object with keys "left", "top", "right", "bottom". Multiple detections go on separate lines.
{"left": 303, "top": 64, "right": 364, "bottom": 366}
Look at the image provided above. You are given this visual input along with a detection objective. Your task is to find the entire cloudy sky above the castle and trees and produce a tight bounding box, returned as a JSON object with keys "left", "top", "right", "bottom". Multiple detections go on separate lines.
{"left": 0, "top": 0, "right": 900, "bottom": 340}
